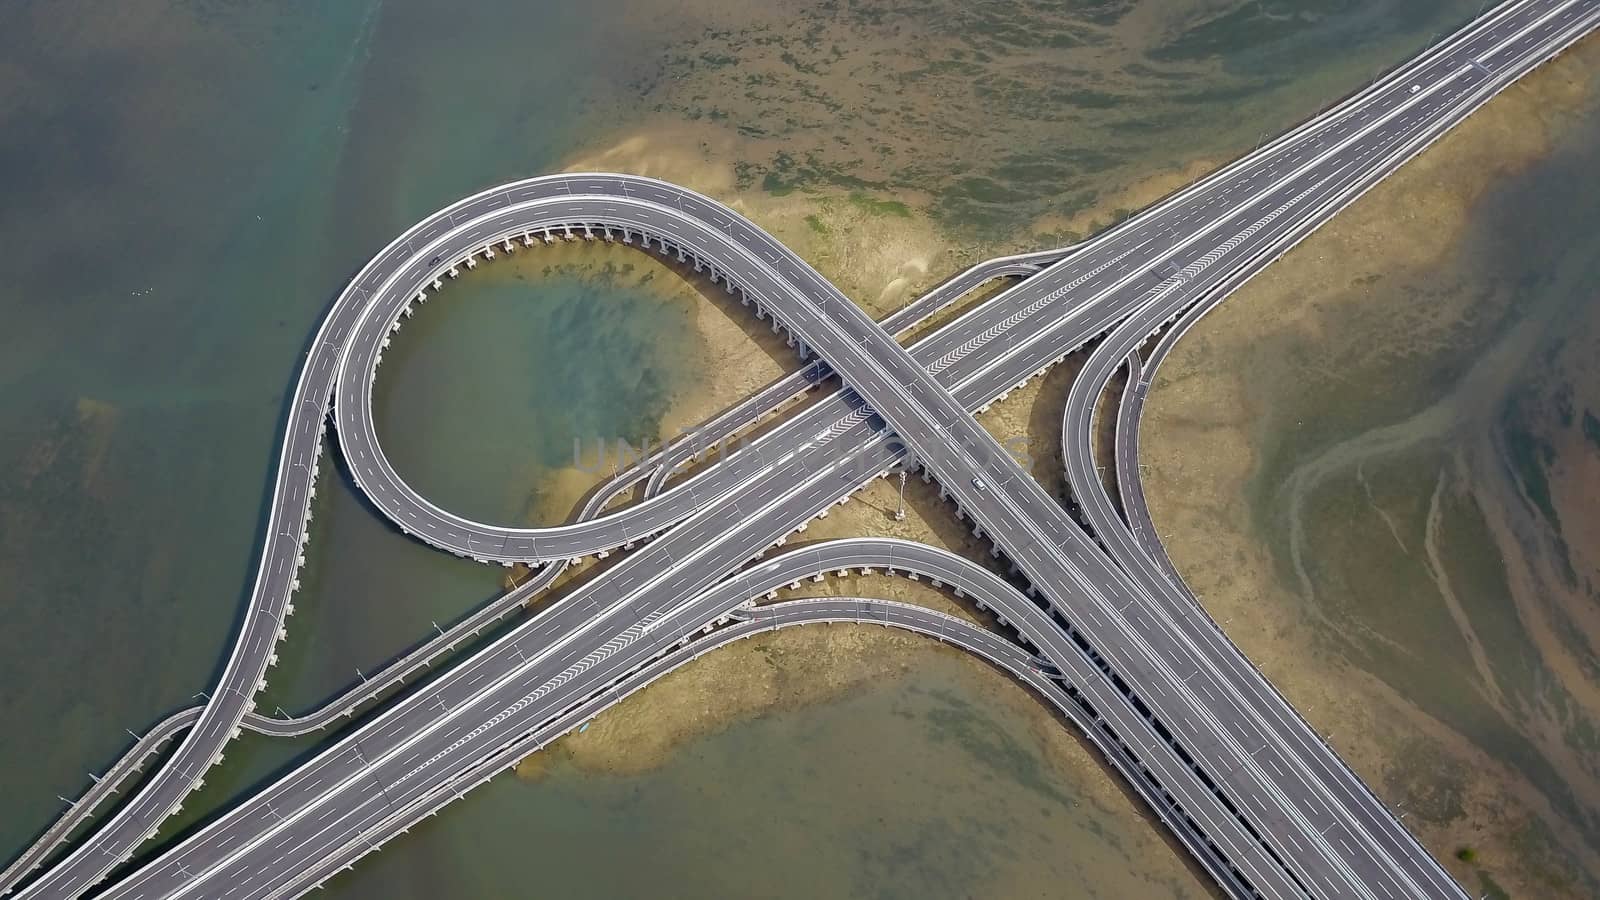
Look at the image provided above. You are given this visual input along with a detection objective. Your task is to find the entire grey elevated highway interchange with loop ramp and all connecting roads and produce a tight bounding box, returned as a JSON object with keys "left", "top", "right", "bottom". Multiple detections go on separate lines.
{"left": 0, "top": 0, "right": 1600, "bottom": 898}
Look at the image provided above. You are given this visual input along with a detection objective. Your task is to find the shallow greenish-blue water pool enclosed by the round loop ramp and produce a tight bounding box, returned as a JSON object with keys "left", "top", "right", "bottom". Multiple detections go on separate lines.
{"left": 374, "top": 259, "right": 698, "bottom": 524}
